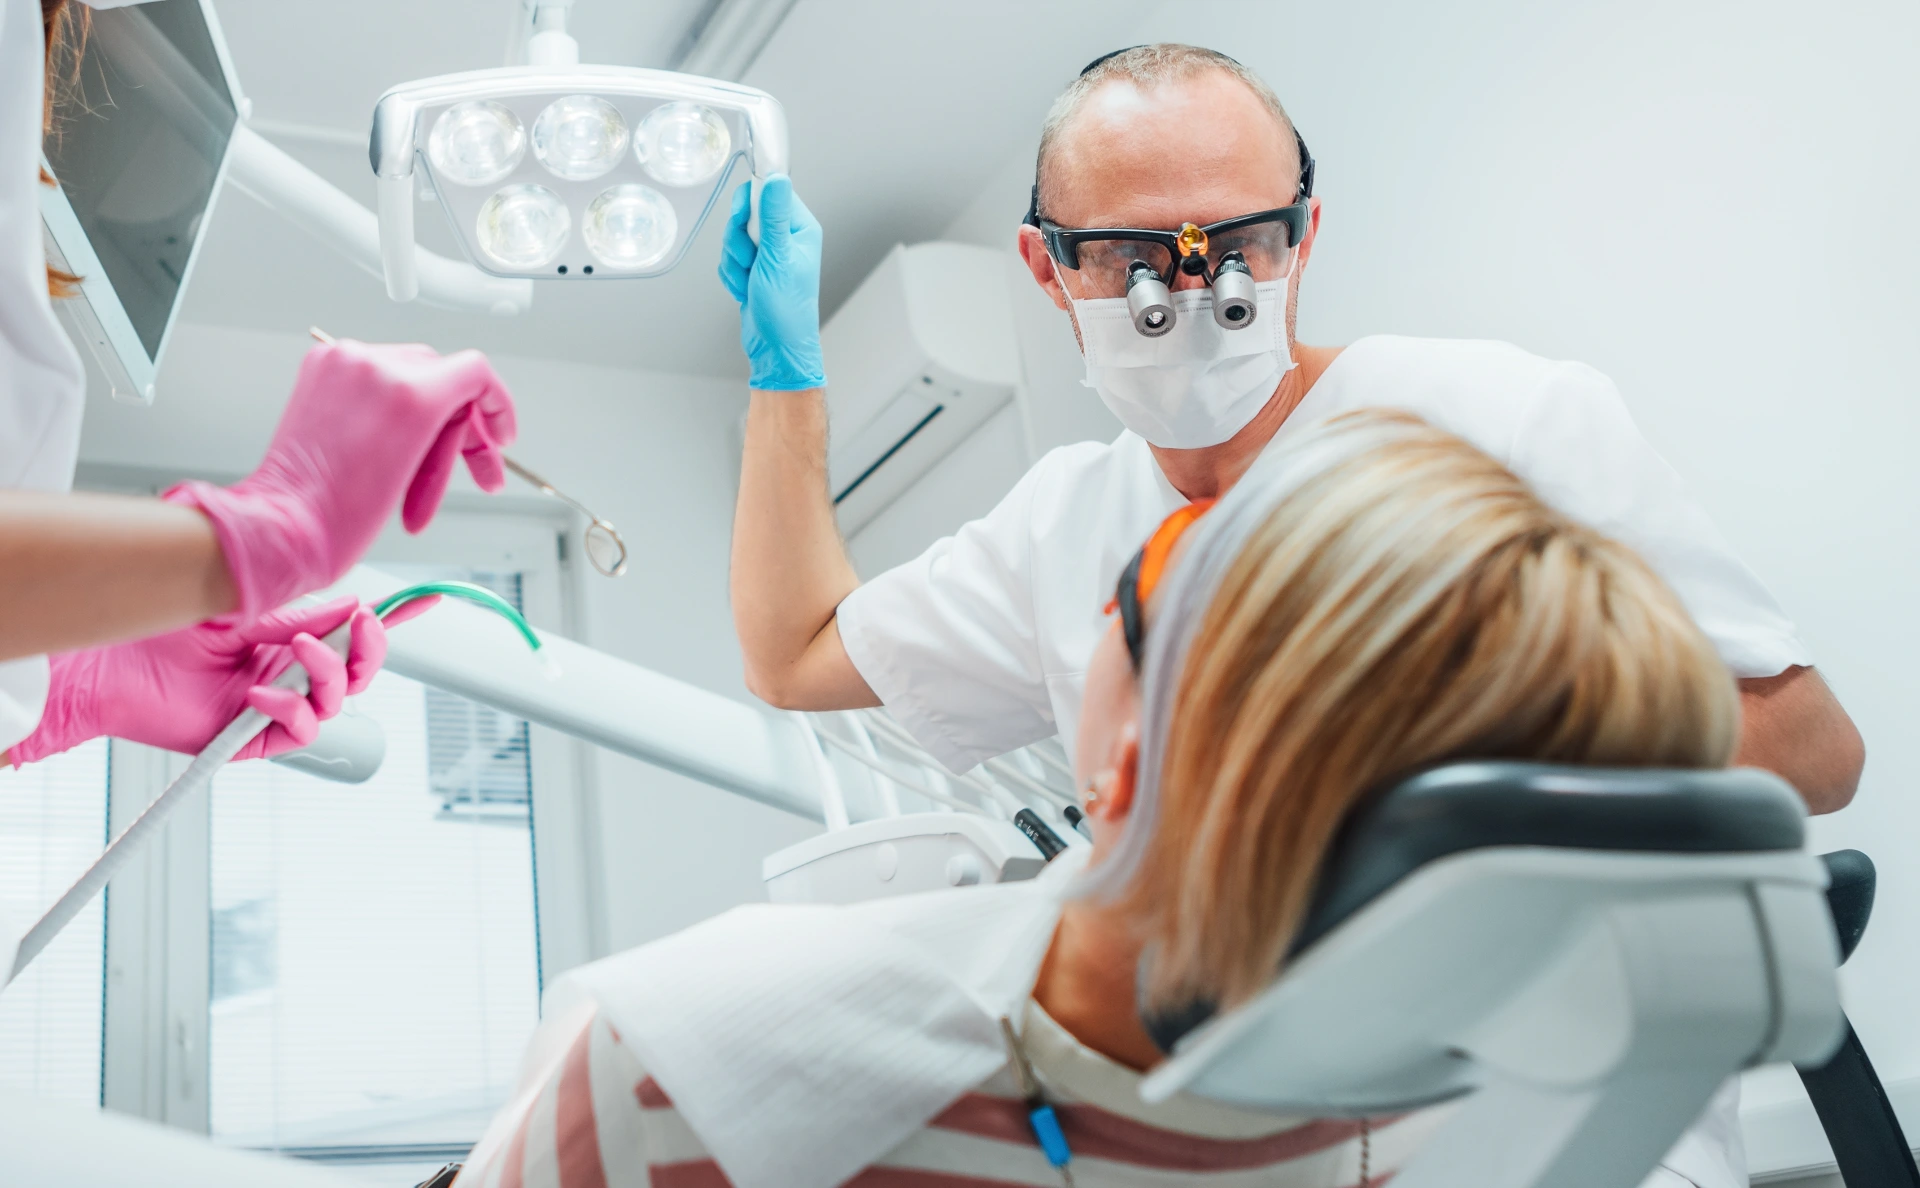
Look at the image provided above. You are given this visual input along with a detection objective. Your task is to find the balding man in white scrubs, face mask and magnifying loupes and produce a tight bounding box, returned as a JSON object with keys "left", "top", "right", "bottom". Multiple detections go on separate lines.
{"left": 720, "top": 44, "right": 1864, "bottom": 812}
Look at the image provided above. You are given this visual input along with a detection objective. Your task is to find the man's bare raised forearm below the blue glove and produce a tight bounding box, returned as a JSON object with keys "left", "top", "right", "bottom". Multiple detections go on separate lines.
{"left": 730, "top": 390, "right": 879, "bottom": 710}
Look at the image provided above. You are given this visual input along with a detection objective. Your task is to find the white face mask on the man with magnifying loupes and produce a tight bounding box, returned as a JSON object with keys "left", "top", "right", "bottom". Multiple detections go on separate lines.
{"left": 1073, "top": 274, "right": 1294, "bottom": 449}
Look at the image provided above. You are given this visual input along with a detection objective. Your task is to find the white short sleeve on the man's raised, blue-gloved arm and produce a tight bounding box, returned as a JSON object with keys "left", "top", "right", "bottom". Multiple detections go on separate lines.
{"left": 837, "top": 461, "right": 1054, "bottom": 772}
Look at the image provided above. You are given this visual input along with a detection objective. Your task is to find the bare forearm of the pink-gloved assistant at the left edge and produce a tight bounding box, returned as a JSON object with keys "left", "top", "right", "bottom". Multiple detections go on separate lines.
{"left": 0, "top": 491, "right": 240, "bottom": 660}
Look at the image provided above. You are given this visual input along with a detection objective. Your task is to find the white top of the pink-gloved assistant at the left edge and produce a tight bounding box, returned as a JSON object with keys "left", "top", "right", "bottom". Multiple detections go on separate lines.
{"left": 0, "top": 0, "right": 84, "bottom": 750}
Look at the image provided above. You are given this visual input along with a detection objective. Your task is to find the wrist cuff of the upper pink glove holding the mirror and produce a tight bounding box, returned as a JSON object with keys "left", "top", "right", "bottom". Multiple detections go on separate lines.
{"left": 161, "top": 480, "right": 332, "bottom": 622}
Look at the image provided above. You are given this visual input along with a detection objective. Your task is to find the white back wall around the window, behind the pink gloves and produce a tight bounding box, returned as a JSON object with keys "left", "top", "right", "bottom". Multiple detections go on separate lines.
{"left": 81, "top": 324, "right": 818, "bottom": 967}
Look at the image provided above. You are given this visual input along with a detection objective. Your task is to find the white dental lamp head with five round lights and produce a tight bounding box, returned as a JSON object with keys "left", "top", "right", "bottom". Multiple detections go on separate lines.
{"left": 369, "top": 2, "right": 787, "bottom": 301}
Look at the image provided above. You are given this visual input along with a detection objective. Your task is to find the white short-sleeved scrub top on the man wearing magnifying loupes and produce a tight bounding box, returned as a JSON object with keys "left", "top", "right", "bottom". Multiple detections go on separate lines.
{"left": 839, "top": 336, "right": 1812, "bottom": 772}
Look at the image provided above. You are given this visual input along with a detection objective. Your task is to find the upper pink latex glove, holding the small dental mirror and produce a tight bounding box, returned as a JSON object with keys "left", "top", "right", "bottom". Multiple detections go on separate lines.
{"left": 165, "top": 340, "right": 516, "bottom": 622}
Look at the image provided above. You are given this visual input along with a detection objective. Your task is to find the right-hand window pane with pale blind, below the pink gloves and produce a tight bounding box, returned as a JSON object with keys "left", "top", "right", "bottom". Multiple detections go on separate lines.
{"left": 209, "top": 660, "right": 540, "bottom": 1153}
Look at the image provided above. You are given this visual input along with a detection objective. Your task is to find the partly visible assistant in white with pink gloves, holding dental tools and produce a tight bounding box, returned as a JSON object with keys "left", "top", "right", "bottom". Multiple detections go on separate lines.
{"left": 0, "top": 0, "right": 515, "bottom": 763}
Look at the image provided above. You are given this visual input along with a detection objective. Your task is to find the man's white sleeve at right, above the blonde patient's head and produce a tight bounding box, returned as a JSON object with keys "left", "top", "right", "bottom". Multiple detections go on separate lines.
{"left": 1507, "top": 363, "right": 1812, "bottom": 677}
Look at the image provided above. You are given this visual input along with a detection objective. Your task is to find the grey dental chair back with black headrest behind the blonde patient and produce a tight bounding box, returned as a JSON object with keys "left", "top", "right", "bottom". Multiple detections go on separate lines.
{"left": 1142, "top": 762, "right": 1843, "bottom": 1188}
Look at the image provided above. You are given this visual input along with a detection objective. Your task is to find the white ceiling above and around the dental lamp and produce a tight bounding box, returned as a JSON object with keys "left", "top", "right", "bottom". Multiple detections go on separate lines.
{"left": 182, "top": 0, "right": 1154, "bottom": 376}
